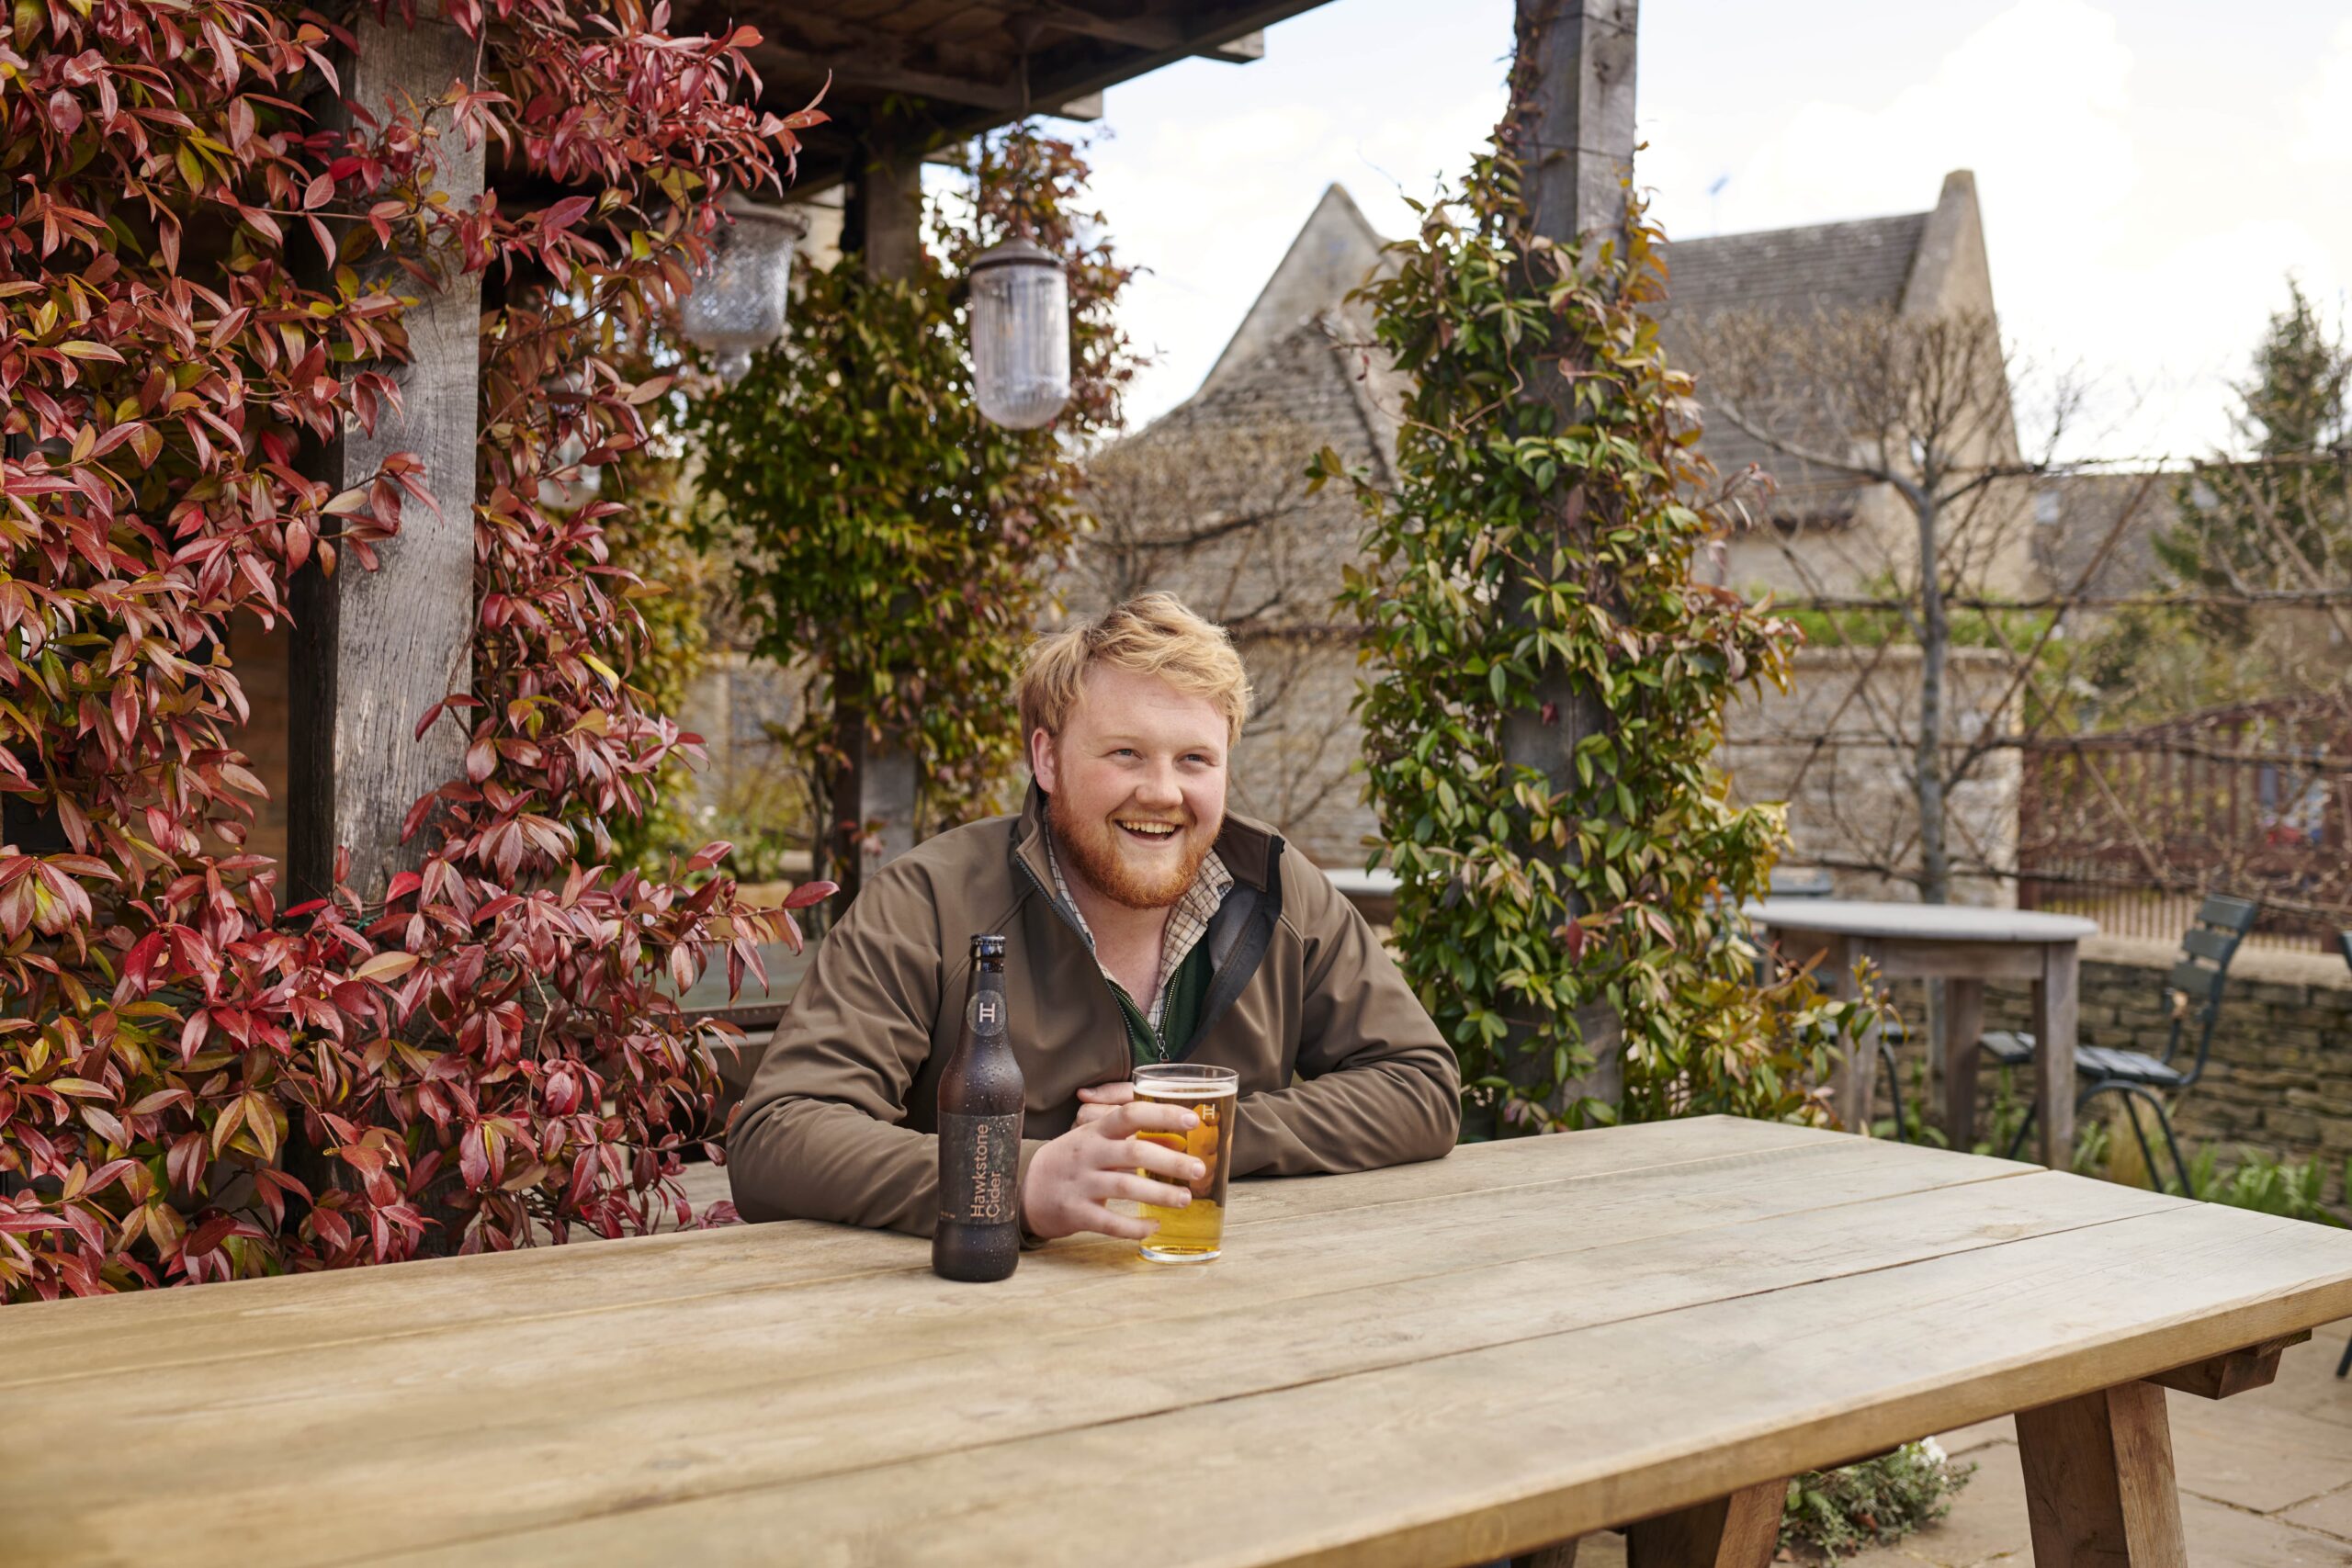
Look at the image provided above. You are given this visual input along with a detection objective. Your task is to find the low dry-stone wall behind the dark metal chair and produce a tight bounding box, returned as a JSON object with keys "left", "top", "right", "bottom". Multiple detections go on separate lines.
{"left": 1905, "top": 938, "right": 2352, "bottom": 1201}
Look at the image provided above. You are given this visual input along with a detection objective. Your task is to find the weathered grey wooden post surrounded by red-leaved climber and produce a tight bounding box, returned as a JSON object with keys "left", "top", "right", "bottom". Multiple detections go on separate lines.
{"left": 287, "top": 18, "right": 482, "bottom": 900}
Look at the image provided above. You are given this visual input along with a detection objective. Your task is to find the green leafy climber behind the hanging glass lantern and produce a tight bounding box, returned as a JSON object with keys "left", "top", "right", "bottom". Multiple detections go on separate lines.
{"left": 696, "top": 130, "right": 1136, "bottom": 884}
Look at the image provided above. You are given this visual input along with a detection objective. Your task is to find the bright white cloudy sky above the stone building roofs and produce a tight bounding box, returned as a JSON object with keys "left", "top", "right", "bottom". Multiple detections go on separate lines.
{"left": 1093, "top": 0, "right": 2352, "bottom": 456}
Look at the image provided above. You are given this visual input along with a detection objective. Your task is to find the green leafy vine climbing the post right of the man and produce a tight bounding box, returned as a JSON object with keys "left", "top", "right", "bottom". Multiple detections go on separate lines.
{"left": 1312, "top": 146, "right": 1844, "bottom": 1135}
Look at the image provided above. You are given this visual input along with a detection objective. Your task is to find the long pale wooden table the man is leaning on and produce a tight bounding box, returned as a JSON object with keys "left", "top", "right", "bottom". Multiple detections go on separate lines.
{"left": 0, "top": 1117, "right": 2352, "bottom": 1568}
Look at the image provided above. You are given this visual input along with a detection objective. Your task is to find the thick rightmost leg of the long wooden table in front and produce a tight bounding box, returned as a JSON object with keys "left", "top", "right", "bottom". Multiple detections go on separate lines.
{"left": 2018, "top": 1382, "right": 2189, "bottom": 1568}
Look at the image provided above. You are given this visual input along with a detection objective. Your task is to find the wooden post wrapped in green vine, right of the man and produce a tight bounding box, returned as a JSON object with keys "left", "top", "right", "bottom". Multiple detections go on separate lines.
{"left": 1503, "top": 0, "right": 1639, "bottom": 1128}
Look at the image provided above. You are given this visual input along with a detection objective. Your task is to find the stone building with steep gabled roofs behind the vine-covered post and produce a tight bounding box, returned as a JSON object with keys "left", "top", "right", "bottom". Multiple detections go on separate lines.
{"left": 1091, "top": 174, "right": 2032, "bottom": 900}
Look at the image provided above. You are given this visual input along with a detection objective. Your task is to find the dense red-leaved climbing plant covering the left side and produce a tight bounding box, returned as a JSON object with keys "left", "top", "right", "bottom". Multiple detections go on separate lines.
{"left": 0, "top": 0, "right": 826, "bottom": 1303}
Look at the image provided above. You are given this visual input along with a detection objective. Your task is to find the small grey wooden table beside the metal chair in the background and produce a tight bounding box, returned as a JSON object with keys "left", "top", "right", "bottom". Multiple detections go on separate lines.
{"left": 1747, "top": 898, "right": 2098, "bottom": 1170}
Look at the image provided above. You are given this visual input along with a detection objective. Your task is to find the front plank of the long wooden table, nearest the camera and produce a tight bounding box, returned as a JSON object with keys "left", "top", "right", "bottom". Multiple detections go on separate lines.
{"left": 371, "top": 1203, "right": 2352, "bottom": 1568}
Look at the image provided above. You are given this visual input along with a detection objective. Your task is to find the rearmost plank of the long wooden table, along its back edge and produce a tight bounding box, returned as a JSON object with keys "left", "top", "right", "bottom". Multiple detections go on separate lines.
{"left": 0, "top": 1117, "right": 1844, "bottom": 1394}
